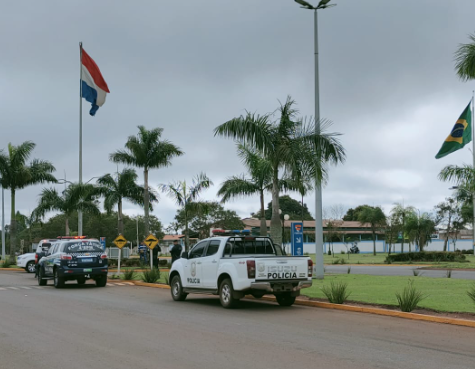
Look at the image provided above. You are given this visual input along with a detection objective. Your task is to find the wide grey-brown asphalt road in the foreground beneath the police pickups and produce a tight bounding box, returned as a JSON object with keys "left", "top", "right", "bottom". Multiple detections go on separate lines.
{"left": 0, "top": 271, "right": 475, "bottom": 369}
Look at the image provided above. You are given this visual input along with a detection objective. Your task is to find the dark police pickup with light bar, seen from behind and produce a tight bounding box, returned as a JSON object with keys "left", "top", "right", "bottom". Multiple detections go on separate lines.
{"left": 38, "top": 239, "right": 108, "bottom": 288}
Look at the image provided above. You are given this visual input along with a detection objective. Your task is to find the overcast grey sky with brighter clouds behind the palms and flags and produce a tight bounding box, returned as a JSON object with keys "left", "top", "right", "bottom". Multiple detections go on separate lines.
{"left": 0, "top": 0, "right": 475, "bottom": 230}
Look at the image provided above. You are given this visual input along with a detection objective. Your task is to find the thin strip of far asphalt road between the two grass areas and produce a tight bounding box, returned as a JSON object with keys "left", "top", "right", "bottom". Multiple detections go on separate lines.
{"left": 325, "top": 265, "right": 475, "bottom": 280}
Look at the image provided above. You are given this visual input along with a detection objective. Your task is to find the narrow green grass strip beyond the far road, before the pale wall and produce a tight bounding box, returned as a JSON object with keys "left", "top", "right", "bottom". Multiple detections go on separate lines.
{"left": 308, "top": 253, "right": 475, "bottom": 269}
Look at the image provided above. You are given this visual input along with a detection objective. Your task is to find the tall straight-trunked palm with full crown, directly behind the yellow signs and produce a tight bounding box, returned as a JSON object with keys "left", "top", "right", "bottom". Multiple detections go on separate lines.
{"left": 110, "top": 126, "right": 183, "bottom": 235}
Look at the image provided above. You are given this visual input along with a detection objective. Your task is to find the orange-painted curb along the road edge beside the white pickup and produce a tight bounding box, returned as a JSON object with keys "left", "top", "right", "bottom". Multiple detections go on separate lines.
{"left": 117, "top": 281, "right": 475, "bottom": 328}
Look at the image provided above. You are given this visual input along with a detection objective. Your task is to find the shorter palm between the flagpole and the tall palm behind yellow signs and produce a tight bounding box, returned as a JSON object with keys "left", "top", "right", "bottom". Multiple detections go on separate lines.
{"left": 97, "top": 168, "right": 158, "bottom": 234}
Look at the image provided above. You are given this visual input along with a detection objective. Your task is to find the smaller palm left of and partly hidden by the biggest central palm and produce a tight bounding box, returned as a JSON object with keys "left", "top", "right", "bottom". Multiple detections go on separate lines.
{"left": 218, "top": 144, "right": 272, "bottom": 236}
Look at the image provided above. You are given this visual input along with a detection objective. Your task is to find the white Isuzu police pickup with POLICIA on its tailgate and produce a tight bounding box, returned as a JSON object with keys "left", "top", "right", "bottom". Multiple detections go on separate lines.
{"left": 169, "top": 230, "right": 313, "bottom": 308}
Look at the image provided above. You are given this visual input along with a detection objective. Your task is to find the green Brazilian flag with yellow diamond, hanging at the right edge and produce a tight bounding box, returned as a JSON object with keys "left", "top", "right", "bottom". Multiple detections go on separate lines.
{"left": 435, "top": 103, "right": 472, "bottom": 159}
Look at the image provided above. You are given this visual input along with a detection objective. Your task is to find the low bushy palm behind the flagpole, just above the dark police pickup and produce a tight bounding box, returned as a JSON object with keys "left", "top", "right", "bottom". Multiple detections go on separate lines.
{"left": 33, "top": 183, "right": 100, "bottom": 236}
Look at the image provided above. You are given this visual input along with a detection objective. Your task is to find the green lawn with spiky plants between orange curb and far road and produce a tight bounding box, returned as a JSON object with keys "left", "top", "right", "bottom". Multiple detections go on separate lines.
{"left": 302, "top": 274, "right": 475, "bottom": 313}
